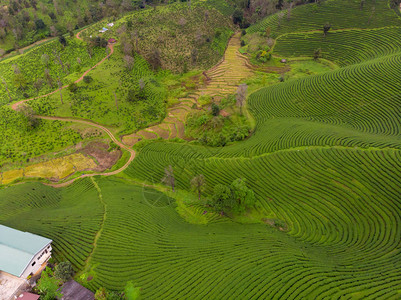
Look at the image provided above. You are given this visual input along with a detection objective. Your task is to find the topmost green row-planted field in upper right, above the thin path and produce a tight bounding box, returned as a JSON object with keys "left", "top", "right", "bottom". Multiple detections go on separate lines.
{"left": 247, "top": 0, "right": 400, "bottom": 38}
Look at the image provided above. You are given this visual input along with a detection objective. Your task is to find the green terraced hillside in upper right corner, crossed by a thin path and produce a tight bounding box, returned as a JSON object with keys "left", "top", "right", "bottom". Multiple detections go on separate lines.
{"left": 247, "top": 0, "right": 401, "bottom": 67}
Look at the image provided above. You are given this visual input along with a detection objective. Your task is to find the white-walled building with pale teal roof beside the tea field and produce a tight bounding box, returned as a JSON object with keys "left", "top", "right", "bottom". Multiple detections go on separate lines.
{"left": 0, "top": 225, "right": 52, "bottom": 278}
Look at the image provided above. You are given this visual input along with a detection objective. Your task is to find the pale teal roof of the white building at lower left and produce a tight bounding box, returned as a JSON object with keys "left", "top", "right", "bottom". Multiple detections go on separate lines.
{"left": 0, "top": 225, "right": 52, "bottom": 276}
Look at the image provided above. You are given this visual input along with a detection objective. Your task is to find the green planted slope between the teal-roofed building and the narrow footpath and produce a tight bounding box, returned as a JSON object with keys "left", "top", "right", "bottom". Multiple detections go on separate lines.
{"left": 0, "top": 180, "right": 104, "bottom": 270}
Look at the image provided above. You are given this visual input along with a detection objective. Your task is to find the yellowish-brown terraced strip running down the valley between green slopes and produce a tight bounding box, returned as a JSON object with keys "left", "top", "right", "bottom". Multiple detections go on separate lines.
{"left": 122, "top": 32, "right": 253, "bottom": 145}
